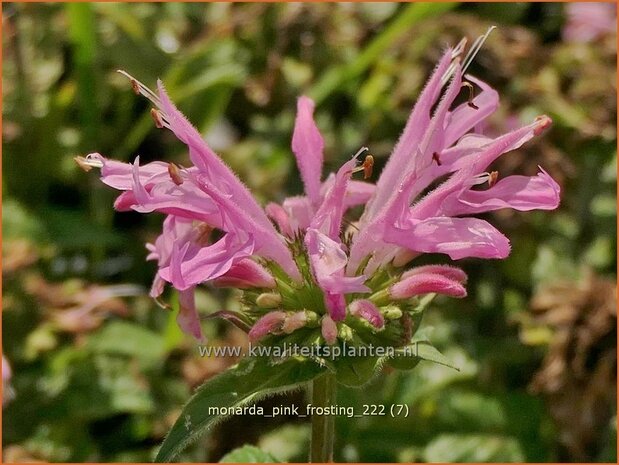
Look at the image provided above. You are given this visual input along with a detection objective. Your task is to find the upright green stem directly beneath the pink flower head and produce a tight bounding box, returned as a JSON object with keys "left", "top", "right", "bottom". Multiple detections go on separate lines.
{"left": 309, "top": 373, "right": 337, "bottom": 463}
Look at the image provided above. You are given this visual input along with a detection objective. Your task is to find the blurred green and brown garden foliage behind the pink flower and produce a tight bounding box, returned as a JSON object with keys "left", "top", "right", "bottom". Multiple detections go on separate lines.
{"left": 2, "top": 3, "right": 617, "bottom": 462}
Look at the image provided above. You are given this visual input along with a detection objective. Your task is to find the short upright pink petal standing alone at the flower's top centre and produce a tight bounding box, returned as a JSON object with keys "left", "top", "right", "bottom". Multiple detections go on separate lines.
{"left": 292, "top": 97, "right": 324, "bottom": 205}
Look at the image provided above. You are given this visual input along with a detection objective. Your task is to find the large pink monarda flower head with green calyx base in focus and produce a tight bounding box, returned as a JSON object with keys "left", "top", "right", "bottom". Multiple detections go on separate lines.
{"left": 78, "top": 40, "right": 559, "bottom": 380}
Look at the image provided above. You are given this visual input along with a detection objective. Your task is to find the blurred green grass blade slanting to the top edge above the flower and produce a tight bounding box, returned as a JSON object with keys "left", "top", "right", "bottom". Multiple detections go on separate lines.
{"left": 309, "top": 2, "right": 458, "bottom": 105}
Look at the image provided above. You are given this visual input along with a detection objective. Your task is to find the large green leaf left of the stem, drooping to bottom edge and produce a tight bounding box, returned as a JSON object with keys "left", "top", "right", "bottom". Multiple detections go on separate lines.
{"left": 155, "top": 357, "right": 326, "bottom": 462}
